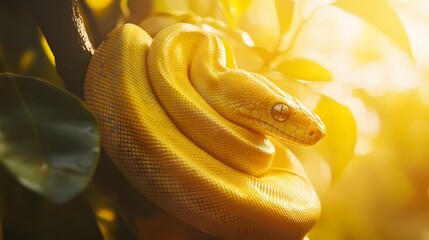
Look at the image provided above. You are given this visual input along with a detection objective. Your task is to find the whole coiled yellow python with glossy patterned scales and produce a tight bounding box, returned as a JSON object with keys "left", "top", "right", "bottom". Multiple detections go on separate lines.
{"left": 85, "top": 23, "right": 325, "bottom": 240}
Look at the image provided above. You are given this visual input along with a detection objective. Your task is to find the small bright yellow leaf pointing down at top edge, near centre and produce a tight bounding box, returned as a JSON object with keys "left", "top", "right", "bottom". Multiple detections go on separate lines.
{"left": 218, "top": 0, "right": 252, "bottom": 28}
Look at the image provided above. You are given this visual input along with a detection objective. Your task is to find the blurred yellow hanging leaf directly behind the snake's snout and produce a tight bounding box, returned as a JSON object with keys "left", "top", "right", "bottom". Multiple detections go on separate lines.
{"left": 314, "top": 96, "right": 357, "bottom": 179}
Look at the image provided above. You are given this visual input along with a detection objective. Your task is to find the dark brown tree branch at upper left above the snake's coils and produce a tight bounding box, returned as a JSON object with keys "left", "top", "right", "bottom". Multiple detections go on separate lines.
{"left": 26, "top": 0, "right": 94, "bottom": 99}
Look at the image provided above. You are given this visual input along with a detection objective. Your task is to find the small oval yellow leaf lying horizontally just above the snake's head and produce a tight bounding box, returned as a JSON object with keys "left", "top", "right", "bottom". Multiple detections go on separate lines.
{"left": 277, "top": 58, "right": 332, "bottom": 81}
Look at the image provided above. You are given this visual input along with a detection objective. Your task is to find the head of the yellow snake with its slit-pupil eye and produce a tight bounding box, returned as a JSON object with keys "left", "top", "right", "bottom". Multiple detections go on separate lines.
{"left": 215, "top": 70, "right": 325, "bottom": 145}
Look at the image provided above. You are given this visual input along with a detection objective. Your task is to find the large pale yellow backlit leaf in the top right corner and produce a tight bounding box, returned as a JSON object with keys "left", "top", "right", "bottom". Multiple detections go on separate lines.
{"left": 333, "top": 0, "right": 413, "bottom": 59}
